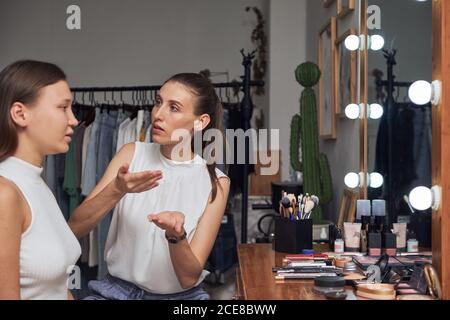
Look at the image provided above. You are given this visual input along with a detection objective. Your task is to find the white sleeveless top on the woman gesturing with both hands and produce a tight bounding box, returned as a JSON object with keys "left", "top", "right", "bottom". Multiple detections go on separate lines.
{"left": 105, "top": 142, "right": 226, "bottom": 294}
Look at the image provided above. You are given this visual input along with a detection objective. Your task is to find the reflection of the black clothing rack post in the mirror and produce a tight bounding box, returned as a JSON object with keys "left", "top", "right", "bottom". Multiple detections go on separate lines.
{"left": 375, "top": 49, "right": 430, "bottom": 226}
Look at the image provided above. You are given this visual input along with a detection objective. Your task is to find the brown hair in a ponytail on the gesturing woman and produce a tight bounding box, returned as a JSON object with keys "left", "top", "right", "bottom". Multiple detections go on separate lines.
{"left": 165, "top": 73, "right": 223, "bottom": 202}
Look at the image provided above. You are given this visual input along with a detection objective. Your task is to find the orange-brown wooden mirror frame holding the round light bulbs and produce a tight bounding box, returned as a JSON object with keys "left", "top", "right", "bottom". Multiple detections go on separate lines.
{"left": 359, "top": 0, "right": 450, "bottom": 300}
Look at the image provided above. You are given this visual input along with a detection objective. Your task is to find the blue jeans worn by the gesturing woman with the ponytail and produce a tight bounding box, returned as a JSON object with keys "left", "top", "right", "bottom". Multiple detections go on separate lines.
{"left": 84, "top": 274, "right": 210, "bottom": 300}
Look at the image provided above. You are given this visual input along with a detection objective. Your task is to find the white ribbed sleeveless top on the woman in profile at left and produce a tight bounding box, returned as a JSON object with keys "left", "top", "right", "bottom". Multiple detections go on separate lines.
{"left": 0, "top": 157, "right": 81, "bottom": 300}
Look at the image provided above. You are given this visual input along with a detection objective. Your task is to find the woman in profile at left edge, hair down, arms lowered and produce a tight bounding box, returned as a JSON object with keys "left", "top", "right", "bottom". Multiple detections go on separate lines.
{"left": 0, "top": 61, "right": 81, "bottom": 300}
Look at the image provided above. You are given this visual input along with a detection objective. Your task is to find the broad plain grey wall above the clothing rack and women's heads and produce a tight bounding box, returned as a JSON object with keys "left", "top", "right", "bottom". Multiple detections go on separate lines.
{"left": 0, "top": 0, "right": 268, "bottom": 121}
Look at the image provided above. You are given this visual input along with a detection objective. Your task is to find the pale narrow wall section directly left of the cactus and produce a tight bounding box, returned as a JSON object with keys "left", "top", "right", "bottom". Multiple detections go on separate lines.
{"left": 268, "top": 0, "right": 307, "bottom": 180}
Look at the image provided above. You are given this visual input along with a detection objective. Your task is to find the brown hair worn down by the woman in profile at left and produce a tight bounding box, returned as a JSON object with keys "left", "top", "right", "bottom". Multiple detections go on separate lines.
{"left": 0, "top": 60, "right": 66, "bottom": 162}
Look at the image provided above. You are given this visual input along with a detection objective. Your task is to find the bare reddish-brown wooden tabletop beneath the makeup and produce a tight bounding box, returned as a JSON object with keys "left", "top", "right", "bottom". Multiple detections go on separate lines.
{"left": 237, "top": 243, "right": 358, "bottom": 300}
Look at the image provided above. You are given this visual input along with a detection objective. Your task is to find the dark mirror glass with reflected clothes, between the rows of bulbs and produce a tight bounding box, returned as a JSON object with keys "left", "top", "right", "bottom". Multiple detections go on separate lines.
{"left": 368, "top": 0, "right": 432, "bottom": 247}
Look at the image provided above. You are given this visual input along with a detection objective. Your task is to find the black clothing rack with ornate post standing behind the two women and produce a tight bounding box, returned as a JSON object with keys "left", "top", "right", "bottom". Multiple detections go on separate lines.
{"left": 71, "top": 49, "right": 265, "bottom": 243}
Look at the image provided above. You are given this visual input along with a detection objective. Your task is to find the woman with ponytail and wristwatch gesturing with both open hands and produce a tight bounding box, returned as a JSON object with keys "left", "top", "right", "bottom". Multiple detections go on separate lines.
{"left": 69, "top": 74, "right": 229, "bottom": 299}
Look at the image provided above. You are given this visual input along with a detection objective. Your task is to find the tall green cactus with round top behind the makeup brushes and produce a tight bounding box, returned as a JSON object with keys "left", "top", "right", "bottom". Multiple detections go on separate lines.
{"left": 290, "top": 62, "right": 333, "bottom": 223}
